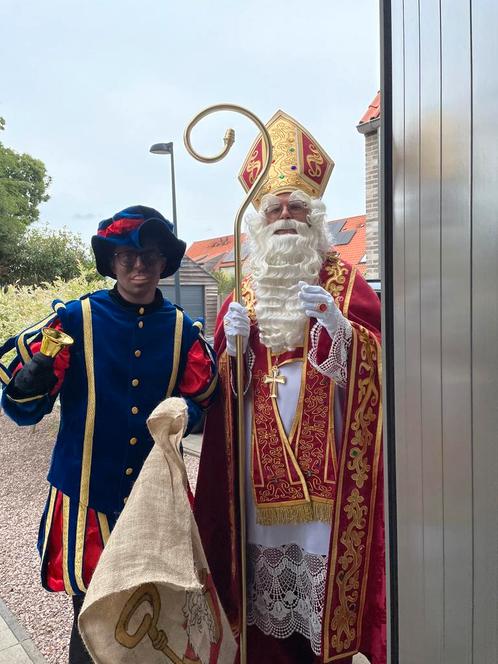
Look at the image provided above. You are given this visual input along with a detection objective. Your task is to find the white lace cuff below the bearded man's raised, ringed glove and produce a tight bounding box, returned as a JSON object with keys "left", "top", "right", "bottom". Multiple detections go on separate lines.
{"left": 308, "top": 316, "right": 353, "bottom": 387}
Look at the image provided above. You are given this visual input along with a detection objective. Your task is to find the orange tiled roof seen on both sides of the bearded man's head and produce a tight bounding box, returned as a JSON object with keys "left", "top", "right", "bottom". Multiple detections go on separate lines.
{"left": 187, "top": 214, "right": 366, "bottom": 273}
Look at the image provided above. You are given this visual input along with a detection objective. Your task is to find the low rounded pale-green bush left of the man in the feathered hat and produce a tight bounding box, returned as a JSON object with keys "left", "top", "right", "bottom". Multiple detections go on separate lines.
{"left": 7, "top": 225, "right": 99, "bottom": 285}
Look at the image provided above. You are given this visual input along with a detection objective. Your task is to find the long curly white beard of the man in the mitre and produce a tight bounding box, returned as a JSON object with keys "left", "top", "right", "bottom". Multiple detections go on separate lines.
{"left": 248, "top": 215, "right": 330, "bottom": 353}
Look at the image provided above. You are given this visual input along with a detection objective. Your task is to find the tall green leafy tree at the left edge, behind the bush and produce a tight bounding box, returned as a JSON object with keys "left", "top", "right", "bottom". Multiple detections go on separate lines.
{"left": 0, "top": 118, "right": 50, "bottom": 281}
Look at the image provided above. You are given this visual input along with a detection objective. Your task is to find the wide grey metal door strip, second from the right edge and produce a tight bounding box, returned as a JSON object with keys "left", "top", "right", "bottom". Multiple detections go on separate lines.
{"left": 441, "top": 0, "right": 473, "bottom": 664}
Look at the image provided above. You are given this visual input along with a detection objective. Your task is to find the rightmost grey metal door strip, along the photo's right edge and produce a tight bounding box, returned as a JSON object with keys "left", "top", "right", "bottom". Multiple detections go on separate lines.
{"left": 472, "top": 0, "right": 498, "bottom": 662}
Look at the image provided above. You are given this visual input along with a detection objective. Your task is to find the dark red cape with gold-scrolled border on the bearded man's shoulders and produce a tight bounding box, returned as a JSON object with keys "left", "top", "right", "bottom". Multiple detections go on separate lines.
{"left": 195, "top": 255, "right": 387, "bottom": 664}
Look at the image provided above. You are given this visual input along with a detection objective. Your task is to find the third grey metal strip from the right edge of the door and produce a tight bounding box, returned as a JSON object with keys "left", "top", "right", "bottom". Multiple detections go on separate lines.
{"left": 419, "top": 0, "right": 444, "bottom": 664}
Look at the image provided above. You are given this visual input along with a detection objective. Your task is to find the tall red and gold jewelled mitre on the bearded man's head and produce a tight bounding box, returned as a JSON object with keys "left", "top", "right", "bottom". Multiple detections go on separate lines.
{"left": 239, "top": 111, "right": 334, "bottom": 209}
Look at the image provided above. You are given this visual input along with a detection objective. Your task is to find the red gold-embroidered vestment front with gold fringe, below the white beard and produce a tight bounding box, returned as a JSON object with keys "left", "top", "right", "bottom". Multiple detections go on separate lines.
{"left": 250, "top": 316, "right": 336, "bottom": 525}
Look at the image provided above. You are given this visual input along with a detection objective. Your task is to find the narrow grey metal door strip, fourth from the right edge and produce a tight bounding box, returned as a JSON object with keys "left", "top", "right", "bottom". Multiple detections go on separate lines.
{"left": 398, "top": 2, "right": 424, "bottom": 663}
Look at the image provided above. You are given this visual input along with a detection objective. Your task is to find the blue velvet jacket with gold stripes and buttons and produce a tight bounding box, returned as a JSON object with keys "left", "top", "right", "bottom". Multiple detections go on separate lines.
{"left": 0, "top": 291, "right": 217, "bottom": 514}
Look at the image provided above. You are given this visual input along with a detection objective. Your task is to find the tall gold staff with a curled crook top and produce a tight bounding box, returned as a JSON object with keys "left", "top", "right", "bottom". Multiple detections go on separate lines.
{"left": 183, "top": 104, "right": 273, "bottom": 664}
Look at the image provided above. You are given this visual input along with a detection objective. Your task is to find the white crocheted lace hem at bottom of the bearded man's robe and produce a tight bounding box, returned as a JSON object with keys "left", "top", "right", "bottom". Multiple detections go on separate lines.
{"left": 247, "top": 544, "right": 327, "bottom": 655}
